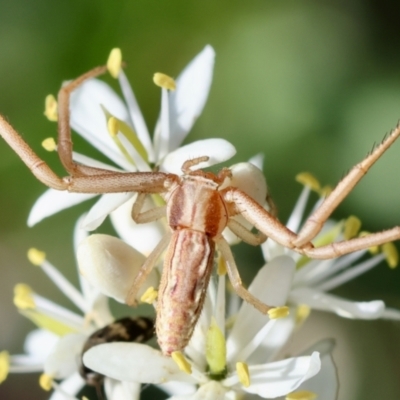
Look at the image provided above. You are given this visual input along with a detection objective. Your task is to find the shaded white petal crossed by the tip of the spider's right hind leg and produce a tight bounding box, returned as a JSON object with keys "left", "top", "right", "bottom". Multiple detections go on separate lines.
{"left": 227, "top": 256, "right": 295, "bottom": 362}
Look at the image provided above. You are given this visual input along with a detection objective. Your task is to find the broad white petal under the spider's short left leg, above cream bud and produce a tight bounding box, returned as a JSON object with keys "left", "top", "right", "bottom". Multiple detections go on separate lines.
{"left": 110, "top": 192, "right": 165, "bottom": 256}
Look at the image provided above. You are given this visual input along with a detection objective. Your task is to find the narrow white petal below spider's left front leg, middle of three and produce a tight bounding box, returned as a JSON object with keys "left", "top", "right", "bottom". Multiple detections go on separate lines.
{"left": 82, "top": 193, "right": 133, "bottom": 231}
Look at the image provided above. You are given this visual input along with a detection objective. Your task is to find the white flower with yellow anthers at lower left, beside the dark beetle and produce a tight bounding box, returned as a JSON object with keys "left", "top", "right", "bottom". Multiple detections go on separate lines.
{"left": 0, "top": 222, "right": 148, "bottom": 400}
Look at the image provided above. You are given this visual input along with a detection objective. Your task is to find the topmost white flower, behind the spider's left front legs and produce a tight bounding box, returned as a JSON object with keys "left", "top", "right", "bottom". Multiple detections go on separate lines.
{"left": 28, "top": 46, "right": 235, "bottom": 254}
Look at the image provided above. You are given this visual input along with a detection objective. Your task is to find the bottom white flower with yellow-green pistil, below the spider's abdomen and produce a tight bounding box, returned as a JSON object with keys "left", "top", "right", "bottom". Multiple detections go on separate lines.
{"left": 84, "top": 256, "right": 337, "bottom": 400}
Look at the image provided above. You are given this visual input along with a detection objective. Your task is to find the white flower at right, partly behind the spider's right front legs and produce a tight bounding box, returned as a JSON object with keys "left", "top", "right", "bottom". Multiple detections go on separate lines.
{"left": 262, "top": 170, "right": 400, "bottom": 319}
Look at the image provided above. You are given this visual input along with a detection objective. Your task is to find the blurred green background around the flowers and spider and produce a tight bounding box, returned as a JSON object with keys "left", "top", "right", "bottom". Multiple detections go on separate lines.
{"left": 0, "top": 0, "right": 400, "bottom": 400}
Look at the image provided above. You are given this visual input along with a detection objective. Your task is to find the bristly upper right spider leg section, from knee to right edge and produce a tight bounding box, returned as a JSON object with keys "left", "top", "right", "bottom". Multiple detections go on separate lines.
{"left": 293, "top": 124, "right": 400, "bottom": 247}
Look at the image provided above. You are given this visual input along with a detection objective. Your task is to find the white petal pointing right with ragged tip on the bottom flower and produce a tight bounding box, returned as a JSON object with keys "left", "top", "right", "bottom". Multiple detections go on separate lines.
{"left": 228, "top": 352, "right": 321, "bottom": 399}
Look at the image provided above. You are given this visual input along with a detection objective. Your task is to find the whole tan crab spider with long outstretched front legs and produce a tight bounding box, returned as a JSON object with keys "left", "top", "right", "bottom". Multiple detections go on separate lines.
{"left": 0, "top": 66, "right": 400, "bottom": 355}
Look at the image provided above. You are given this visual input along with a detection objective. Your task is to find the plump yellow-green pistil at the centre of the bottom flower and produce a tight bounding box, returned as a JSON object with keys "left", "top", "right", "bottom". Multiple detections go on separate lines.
{"left": 206, "top": 317, "right": 226, "bottom": 374}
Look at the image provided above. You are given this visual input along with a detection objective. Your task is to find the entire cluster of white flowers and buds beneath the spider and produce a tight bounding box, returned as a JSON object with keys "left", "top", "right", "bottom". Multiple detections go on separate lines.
{"left": 0, "top": 46, "right": 400, "bottom": 400}
